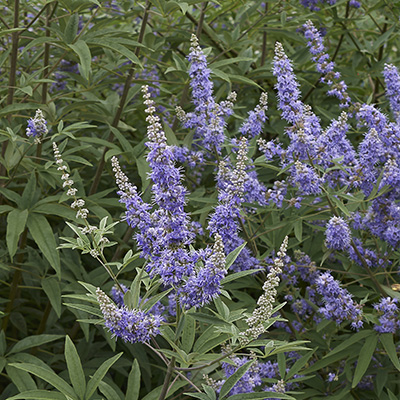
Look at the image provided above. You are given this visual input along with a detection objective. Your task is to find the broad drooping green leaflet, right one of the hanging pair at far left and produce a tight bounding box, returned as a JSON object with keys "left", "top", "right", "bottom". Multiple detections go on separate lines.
{"left": 27, "top": 213, "right": 61, "bottom": 275}
